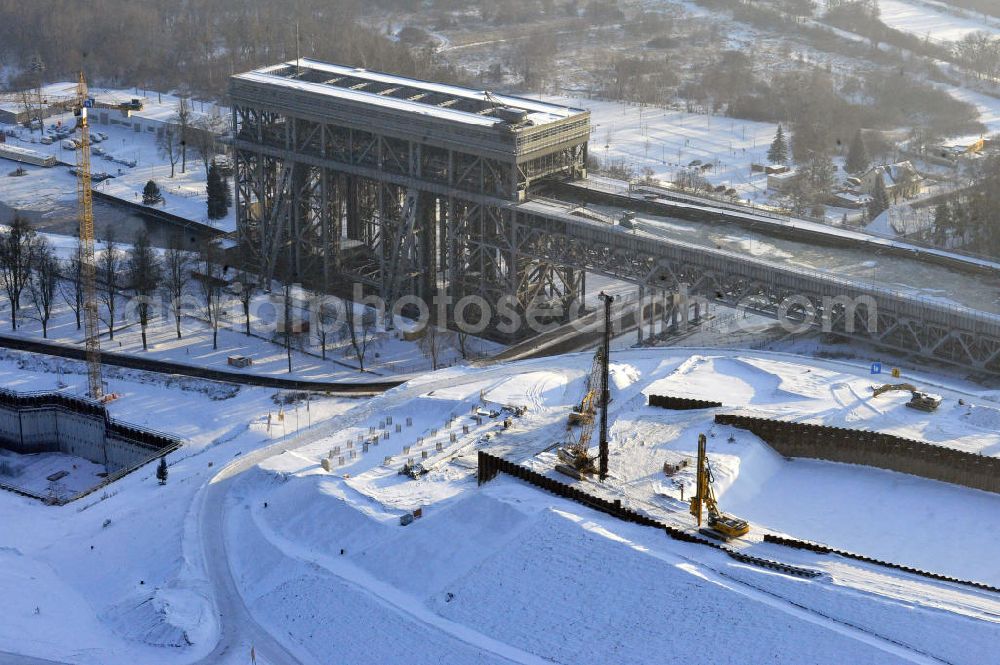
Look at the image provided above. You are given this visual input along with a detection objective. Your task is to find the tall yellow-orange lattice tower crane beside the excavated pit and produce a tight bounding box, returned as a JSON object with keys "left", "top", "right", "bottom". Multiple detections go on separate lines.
{"left": 74, "top": 72, "right": 104, "bottom": 400}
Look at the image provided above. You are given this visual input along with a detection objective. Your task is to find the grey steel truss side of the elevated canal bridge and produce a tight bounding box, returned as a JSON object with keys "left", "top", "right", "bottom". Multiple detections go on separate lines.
{"left": 514, "top": 211, "right": 1000, "bottom": 372}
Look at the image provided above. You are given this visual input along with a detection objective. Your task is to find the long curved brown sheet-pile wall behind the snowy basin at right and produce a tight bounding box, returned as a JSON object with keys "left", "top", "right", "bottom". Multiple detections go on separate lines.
{"left": 715, "top": 414, "right": 1000, "bottom": 493}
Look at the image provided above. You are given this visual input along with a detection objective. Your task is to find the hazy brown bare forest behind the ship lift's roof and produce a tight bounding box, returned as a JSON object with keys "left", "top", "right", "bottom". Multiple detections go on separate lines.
{"left": 0, "top": 0, "right": 452, "bottom": 98}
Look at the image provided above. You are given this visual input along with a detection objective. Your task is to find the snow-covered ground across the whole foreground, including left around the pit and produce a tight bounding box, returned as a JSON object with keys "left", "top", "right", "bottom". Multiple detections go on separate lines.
{"left": 0, "top": 349, "right": 1000, "bottom": 665}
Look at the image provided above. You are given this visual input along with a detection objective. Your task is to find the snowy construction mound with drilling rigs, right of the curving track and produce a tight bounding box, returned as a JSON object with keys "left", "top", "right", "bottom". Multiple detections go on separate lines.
{"left": 219, "top": 350, "right": 1000, "bottom": 663}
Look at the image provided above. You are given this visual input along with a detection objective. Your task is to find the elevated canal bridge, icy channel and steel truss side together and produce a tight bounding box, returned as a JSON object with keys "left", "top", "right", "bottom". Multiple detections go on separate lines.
{"left": 513, "top": 192, "right": 1000, "bottom": 373}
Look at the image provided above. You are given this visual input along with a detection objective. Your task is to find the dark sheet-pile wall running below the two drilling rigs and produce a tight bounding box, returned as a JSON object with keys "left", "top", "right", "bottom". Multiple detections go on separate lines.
{"left": 478, "top": 450, "right": 822, "bottom": 578}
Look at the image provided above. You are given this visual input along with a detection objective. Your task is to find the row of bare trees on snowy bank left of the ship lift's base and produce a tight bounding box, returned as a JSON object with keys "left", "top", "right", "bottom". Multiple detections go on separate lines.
{"left": 0, "top": 216, "right": 394, "bottom": 371}
